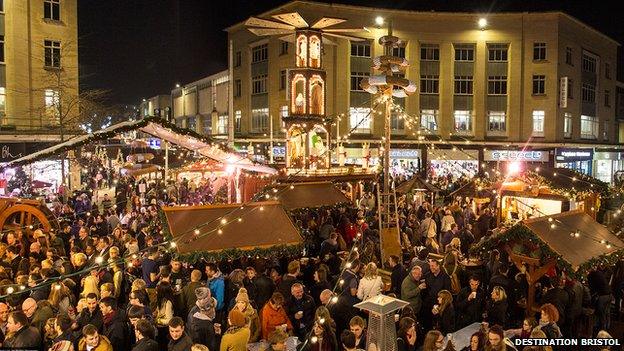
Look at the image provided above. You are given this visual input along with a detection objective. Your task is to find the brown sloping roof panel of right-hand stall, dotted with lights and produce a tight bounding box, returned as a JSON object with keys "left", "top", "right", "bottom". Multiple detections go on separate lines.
{"left": 523, "top": 211, "right": 624, "bottom": 270}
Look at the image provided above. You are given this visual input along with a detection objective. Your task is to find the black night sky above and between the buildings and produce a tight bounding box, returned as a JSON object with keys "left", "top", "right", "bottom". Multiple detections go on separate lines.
{"left": 78, "top": 0, "right": 624, "bottom": 104}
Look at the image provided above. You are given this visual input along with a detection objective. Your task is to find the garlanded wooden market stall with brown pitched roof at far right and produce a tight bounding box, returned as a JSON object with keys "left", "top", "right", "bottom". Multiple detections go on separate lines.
{"left": 473, "top": 210, "right": 624, "bottom": 314}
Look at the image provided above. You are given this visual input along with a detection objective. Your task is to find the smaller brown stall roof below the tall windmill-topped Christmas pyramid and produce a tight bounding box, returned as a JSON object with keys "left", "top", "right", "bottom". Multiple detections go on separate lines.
{"left": 269, "top": 182, "right": 350, "bottom": 210}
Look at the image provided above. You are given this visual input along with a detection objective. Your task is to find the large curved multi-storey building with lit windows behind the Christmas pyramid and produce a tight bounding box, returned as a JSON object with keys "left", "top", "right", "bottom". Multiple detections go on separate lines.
{"left": 221, "top": 1, "right": 624, "bottom": 181}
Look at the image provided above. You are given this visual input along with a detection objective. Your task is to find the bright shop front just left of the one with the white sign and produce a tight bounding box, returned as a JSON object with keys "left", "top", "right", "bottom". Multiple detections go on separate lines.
{"left": 427, "top": 149, "right": 479, "bottom": 179}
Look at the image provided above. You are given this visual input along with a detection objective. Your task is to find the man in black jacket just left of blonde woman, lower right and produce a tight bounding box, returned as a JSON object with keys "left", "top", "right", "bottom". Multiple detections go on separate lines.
{"left": 455, "top": 276, "right": 485, "bottom": 329}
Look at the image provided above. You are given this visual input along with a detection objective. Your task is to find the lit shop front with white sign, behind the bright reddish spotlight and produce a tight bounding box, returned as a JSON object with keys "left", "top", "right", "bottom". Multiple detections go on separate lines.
{"left": 483, "top": 150, "right": 550, "bottom": 172}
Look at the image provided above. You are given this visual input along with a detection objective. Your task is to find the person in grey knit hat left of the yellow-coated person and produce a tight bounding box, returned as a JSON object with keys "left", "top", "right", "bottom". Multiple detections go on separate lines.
{"left": 187, "top": 286, "right": 219, "bottom": 350}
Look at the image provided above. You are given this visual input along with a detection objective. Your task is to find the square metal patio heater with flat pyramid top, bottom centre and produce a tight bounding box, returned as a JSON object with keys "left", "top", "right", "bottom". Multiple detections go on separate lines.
{"left": 355, "top": 295, "right": 409, "bottom": 351}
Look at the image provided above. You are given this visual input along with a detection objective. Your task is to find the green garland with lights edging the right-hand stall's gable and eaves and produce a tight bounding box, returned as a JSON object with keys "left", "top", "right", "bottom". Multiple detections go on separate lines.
{"left": 470, "top": 224, "right": 624, "bottom": 280}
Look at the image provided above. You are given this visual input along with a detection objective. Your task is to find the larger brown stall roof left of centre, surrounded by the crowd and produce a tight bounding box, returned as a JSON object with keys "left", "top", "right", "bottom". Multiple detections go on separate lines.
{"left": 163, "top": 201, "right": 302, "bottom": 254}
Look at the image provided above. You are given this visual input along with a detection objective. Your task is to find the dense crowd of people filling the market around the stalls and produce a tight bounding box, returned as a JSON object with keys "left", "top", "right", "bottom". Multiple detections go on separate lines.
{"left": 0, "top": 171, "right": 624, "bottom": 351}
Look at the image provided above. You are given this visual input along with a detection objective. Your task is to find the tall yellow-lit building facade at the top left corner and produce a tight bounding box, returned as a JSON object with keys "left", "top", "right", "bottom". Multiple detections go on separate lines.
{"left": 0, "top": 0, "right": 78, "bottom": 136}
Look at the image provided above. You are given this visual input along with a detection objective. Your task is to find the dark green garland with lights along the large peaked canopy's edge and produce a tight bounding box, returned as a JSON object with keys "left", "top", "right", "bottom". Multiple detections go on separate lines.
{"left": 0, "top": 116, "right": 225, "bottom": 171}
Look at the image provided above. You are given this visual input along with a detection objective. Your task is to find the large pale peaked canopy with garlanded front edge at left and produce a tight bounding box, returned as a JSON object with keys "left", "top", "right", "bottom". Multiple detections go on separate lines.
{"left": 2, "top": 117, "right": 277, "bottom": 174}
